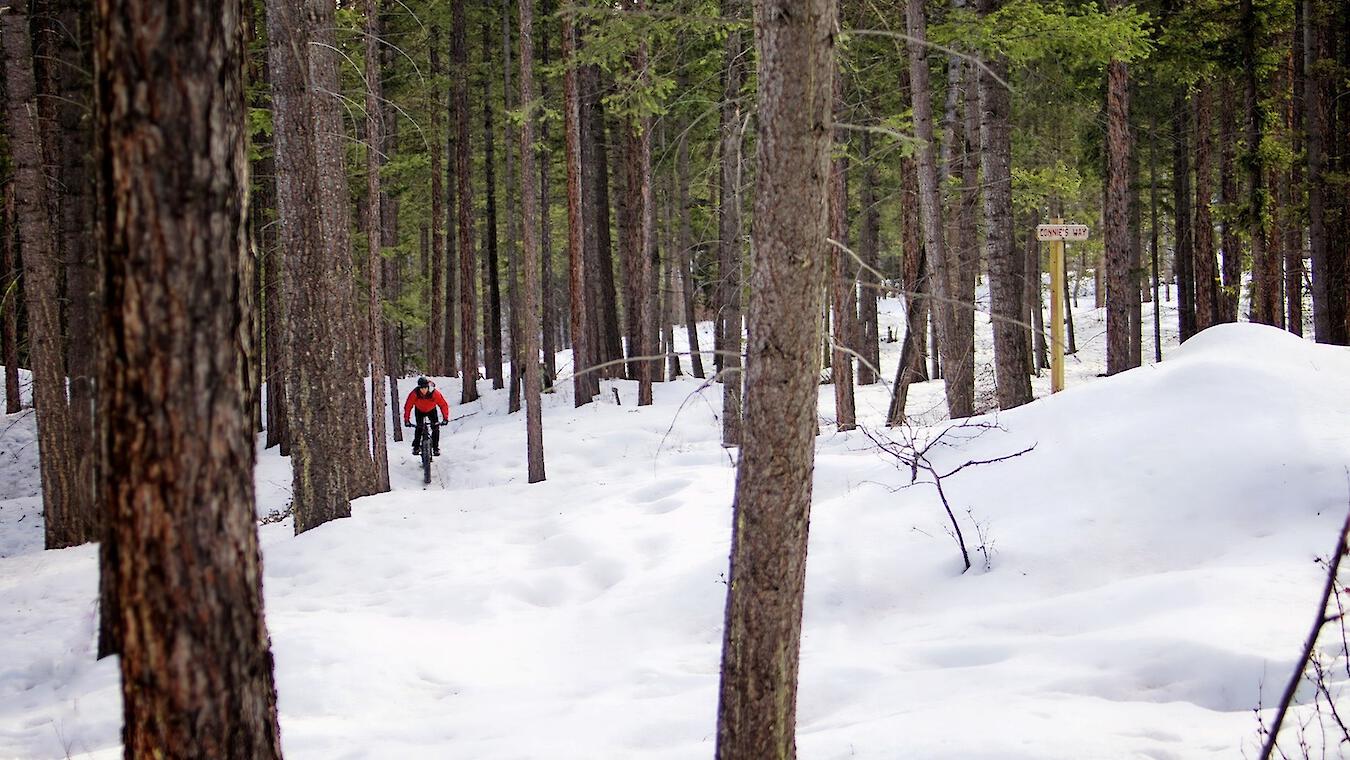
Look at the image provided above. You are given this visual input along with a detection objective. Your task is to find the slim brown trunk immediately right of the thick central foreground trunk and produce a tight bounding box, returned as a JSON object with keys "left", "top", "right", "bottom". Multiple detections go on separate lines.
{"left": 821, "top": 77, "right": 857, "bottom": 432}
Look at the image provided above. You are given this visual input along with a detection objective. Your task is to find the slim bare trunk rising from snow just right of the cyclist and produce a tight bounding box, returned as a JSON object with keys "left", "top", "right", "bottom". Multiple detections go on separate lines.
{"left": 514, "top": 0, "right": 544, "bottom": 483}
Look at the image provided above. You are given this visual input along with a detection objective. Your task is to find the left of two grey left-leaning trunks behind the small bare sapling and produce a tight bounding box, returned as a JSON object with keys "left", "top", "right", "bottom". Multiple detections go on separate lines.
{"left": 905, "top": 0, "right": 975, "bottom": 418}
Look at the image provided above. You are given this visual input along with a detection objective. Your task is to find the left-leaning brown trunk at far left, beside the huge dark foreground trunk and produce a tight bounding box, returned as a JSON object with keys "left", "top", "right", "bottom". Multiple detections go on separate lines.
{"left": 0, "top": 0, "right": 81, "bottom": 549}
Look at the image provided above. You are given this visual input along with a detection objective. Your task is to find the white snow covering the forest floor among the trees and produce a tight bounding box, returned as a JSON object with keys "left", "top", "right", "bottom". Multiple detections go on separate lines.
{"left": 0, "top": 288, "right": 1350, "bottom": 760}
